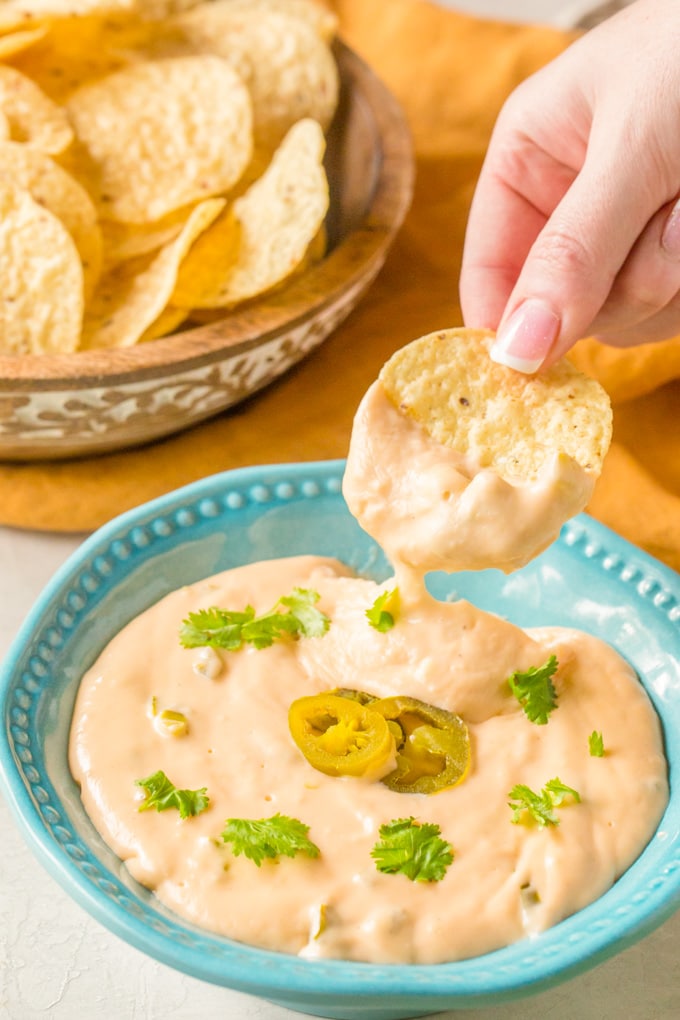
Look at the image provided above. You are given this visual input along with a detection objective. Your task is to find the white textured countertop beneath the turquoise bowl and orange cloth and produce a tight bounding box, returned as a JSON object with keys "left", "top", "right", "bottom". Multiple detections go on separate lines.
{"left": 0, "top": 0, "right": 680, "bottom": 1020}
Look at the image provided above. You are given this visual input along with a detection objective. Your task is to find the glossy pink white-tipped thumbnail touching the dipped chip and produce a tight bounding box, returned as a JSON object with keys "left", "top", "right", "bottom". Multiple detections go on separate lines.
{"left": 490, "top": 298, "right": 560, "bottom": 374}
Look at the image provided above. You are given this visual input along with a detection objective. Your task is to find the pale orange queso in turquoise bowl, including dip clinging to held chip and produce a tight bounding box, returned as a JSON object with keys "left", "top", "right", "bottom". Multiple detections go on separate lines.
{"left": 69, "top": 381, "right": 668, "bottom": 963}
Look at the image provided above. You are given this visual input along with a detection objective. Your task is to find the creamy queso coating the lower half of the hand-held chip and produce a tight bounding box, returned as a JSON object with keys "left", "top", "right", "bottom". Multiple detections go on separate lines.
{"left": 343, "top": 381, "right": 594, "bottom": 591}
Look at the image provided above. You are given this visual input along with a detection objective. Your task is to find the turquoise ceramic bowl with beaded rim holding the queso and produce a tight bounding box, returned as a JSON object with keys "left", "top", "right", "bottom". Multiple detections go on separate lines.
{"left": 0, "top": 461, "right": 680, "bottom": 1020}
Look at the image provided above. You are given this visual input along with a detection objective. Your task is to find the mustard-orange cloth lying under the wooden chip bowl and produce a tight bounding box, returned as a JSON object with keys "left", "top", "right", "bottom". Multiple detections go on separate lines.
{"left": 0, "top": 0, "right": 680, "bottom": 569}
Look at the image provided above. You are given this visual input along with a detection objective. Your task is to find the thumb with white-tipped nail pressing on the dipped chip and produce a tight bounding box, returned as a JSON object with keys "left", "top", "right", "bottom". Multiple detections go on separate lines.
{"left": 491, "top": 149, "right": 660, "bottom": 372}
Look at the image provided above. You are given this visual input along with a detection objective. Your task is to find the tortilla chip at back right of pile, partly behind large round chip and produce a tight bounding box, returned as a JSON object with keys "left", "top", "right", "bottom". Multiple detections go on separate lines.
{"left": 172, "top": 0, "right": 339, "bottom": 152}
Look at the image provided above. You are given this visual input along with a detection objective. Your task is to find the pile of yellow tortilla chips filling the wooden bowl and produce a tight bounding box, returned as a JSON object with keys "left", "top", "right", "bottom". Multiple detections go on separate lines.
{"left": 0, "top": 0, "right": 338, "bottom": 355}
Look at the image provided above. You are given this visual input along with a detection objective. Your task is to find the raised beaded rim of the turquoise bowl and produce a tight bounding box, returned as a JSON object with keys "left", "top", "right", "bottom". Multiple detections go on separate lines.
{"left": 0, "top": 461, "right": 680, "bottom": 1007}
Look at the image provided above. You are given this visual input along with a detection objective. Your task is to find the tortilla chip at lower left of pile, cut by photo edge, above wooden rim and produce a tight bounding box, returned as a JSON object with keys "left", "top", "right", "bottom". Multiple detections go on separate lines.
{"left": 0, "top": 181, "right": 84, "bottom": 355}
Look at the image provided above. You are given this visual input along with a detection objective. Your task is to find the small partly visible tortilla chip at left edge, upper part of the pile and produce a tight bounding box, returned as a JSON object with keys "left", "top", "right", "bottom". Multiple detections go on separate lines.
{"left": 0, "top": 64, "right": 73, "bottom": 155}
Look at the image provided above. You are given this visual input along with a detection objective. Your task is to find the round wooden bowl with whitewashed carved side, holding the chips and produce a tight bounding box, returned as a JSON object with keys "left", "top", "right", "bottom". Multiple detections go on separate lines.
{"left": 0, "top": 42, "right": 414, "bottom": 460}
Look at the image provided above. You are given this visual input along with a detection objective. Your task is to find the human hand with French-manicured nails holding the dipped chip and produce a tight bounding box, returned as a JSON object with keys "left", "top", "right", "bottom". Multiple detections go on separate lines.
{"left": 461, "top": 0, "right": 680, "bottom": 372}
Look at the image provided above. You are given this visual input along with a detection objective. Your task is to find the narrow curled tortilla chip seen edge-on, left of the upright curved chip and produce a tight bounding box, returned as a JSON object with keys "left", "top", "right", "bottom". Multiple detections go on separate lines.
{"left": 81, "top": 198, "right": 225, "bottom": 349}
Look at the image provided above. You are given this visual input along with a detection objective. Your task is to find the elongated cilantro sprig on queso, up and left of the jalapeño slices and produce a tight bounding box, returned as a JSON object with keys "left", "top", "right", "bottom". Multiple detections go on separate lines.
{"left": 179, "top": 588, "right": 330, "bottom": 652}
